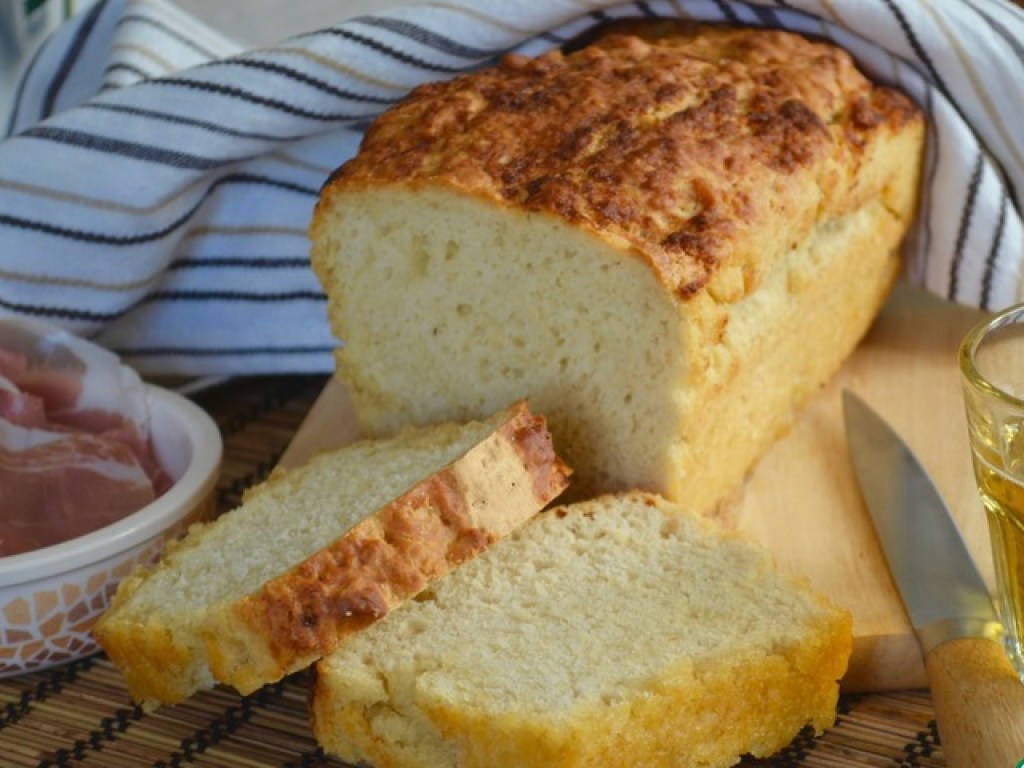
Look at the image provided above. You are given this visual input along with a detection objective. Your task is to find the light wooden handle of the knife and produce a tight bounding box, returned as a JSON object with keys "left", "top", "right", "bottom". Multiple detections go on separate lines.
{"left": 925, "top": 637, "right": 1024, "bottom": 768}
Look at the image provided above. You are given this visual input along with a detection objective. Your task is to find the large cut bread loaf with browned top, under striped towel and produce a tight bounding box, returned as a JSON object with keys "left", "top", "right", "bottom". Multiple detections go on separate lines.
{"left": 310, "top": 24, "right": 924, "bottom": 510}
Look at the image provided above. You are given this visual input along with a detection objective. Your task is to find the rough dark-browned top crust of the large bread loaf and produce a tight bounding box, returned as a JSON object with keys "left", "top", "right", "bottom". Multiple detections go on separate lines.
{"left": 321, "top": 23, "right": 922, "bottom": 298}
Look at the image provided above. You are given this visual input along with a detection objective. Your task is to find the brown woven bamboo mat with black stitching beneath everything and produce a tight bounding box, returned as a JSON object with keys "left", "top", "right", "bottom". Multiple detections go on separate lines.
{"left": 0, "top": 377, "right": 946, "bottom": 768}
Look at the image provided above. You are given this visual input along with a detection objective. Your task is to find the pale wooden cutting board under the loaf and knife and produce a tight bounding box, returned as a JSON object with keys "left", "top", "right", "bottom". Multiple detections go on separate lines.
{"left": 282, "top": 286, "right": 992, "bottom": 691}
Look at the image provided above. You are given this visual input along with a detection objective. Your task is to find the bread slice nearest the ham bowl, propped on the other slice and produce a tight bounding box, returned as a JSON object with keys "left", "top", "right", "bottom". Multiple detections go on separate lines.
{"left": 94, "top": 402, "right": 568, "bottom": 707}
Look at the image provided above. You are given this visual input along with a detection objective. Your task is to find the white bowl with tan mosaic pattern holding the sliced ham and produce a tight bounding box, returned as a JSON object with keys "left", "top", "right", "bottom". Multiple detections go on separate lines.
{"left": 0, "top": 386, "right": 222, "bottom": 678}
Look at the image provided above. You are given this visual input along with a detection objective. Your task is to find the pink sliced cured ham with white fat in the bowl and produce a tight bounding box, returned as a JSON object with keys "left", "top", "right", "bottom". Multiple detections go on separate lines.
{"left": 0, "top": 319, "right": 171, "bottom": 556}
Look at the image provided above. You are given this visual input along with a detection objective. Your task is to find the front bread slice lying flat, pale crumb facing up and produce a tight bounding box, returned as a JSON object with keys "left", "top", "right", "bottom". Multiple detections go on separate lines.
{"left": 311, "top": 494, "right": 852, "bottom": 768}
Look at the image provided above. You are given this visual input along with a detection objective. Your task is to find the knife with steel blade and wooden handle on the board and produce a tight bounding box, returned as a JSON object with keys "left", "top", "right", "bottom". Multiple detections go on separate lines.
{"left": 843, "top": 391, "right": 1024, "bottom": 768}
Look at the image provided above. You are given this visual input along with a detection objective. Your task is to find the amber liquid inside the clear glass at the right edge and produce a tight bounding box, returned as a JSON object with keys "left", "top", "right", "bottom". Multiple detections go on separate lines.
{"left": 972, "top": 447, "right": 1024, "bottom": 680}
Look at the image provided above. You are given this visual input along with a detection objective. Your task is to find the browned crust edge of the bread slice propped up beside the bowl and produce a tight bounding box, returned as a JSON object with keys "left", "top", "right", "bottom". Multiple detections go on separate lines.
{"left": 199, "top": 402, "right": 569, "bottom": 693}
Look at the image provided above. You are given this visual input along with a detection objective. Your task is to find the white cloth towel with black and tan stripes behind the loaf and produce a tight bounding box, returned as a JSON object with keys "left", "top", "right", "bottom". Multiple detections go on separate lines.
{"left": 0, "top": 0, "right": 1024, "bottom": 375}
